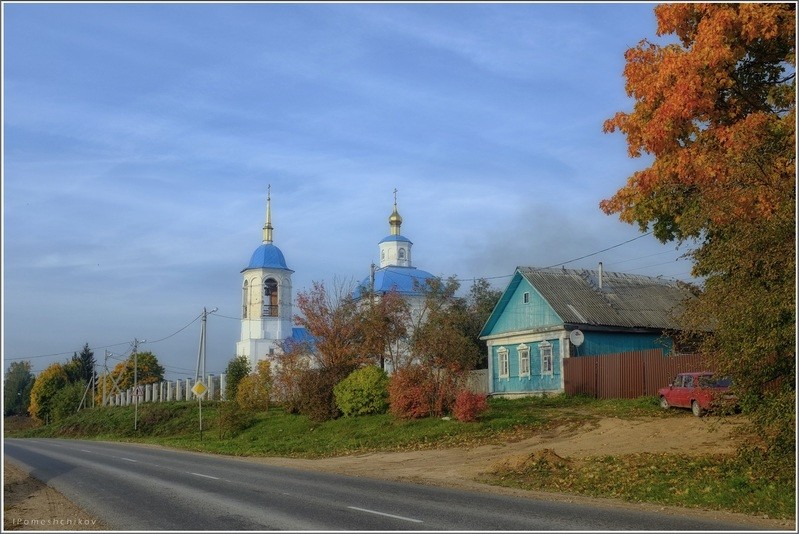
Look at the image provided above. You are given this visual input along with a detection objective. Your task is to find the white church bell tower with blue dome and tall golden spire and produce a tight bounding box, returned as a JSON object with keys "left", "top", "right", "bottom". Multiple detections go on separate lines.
{"left": 236, "top": 186, "right": 310, "bottom": 369}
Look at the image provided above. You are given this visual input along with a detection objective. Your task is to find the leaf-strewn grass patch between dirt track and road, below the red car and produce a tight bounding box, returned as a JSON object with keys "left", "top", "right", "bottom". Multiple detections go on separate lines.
{"left": 482, "top": 453, "right": 796, "bottom": 519}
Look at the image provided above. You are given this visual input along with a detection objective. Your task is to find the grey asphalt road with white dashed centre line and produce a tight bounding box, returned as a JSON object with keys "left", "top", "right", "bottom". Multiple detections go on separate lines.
{"left": 4, "top": 439, "right": 756, "bottom": 531}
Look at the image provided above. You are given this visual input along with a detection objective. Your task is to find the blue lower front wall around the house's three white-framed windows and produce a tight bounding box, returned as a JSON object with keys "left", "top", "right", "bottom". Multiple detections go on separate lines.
{"left": 491, "top": 339, "right": 562, "bottom": 393}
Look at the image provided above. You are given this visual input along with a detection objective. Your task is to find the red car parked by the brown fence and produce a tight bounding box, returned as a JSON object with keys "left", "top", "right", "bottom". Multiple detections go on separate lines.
{"left": 658, "top": 371, "right": 735, "bottom": 417}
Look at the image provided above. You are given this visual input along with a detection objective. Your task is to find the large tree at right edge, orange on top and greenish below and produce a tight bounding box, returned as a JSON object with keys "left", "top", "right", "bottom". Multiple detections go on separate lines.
{"left": 600, "top": 3, "right": 796, "bottom": 464}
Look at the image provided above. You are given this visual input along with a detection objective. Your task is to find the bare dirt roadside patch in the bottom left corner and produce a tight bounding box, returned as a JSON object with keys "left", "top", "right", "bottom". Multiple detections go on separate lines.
{"left": 3, "top": 460, "right": 108, "bottom": 531}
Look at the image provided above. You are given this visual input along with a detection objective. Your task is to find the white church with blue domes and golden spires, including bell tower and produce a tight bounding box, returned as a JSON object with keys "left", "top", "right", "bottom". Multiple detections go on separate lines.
{"left": 236, "top": 192, "right": 435, "bottom": 369}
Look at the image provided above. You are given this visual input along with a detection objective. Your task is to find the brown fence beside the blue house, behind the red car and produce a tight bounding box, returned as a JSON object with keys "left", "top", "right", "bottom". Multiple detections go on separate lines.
{"left": 563, "top": 349, "right": 705, "bottom": 399}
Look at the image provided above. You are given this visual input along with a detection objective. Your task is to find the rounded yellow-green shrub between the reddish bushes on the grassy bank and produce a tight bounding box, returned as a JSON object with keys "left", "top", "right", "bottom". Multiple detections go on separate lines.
{"left": 333, "top": 365, "right": 388, "bottom": 417}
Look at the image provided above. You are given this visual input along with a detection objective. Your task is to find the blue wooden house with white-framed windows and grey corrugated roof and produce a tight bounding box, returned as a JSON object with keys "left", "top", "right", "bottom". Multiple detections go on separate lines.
{"left": 480, "top": 263, "right": 694, "bottom": 396}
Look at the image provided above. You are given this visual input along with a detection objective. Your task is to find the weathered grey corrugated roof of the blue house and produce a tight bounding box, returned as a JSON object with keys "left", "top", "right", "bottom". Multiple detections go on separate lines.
{"left": 517, "top": 267, "right": 694, "bottom": 329}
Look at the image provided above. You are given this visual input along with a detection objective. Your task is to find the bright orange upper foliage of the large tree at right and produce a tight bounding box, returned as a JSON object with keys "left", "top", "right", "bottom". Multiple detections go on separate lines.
{"left": 600, "top": 3, "right": 796, "bottom": 241}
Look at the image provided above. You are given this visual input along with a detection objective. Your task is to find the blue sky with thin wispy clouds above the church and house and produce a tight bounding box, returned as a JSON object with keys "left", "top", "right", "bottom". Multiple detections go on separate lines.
{"left": 2, "top": 2, "right": 692, "bottom": 379}
